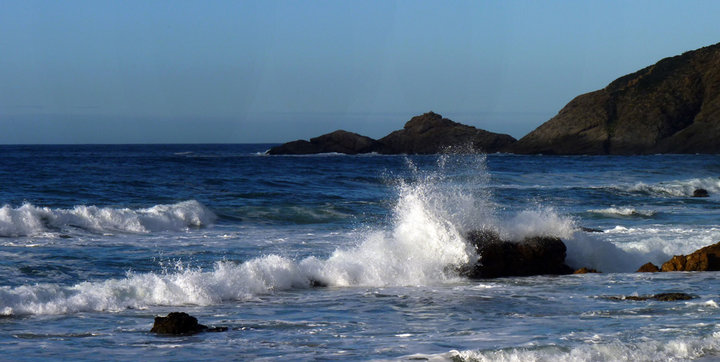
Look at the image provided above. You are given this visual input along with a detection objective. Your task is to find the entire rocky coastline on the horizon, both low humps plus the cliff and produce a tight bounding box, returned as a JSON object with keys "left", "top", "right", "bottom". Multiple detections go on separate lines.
{"left": 268, "top": 43, "right": 720, "bottom": 155}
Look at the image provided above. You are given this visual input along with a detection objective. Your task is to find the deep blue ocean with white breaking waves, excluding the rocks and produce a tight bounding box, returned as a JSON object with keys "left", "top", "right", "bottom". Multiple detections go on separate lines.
{"left": 0, "top": 145, "right": 720, "bottom": 361}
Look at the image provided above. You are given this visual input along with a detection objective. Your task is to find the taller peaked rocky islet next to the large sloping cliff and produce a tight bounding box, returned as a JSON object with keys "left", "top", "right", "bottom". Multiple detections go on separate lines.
{"left": 379, "top": 112, "right": 515, "bottom": 154}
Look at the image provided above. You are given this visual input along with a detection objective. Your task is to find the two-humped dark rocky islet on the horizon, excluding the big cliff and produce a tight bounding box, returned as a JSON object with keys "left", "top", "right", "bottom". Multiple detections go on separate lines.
{"left": 267, "top": 112, "right": 515, "bottom": 155}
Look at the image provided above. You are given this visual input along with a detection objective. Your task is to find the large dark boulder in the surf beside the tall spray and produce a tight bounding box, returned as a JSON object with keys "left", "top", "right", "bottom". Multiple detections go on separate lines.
{"left": 460, "top": 231, "right": 573, "bottom": 279}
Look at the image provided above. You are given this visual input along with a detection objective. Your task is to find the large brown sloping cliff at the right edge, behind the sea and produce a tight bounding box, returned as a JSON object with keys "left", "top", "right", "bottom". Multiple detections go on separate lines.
{"left": 504, "top": 43, "right": 720, "bottom": 154}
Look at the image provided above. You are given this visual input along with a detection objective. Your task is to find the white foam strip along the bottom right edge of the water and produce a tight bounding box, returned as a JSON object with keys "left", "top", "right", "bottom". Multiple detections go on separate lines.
{"left": 402, "top": 332, "right": 720, "bottom": 362}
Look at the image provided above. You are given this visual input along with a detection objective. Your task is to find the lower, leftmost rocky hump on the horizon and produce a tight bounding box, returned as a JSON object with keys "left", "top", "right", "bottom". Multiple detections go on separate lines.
{"left": 267, "top": 130, "right": 381, "bottom": 155}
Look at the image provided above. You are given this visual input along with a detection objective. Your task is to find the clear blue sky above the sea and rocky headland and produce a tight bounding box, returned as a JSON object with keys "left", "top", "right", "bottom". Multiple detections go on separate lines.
{"left": 0, "top": 0, "right": 720, "bottom": 144}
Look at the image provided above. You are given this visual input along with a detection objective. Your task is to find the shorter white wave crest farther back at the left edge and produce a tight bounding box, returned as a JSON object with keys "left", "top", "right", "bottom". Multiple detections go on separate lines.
{"left": 0, "top": 200, "right": 216, "bottom": 237}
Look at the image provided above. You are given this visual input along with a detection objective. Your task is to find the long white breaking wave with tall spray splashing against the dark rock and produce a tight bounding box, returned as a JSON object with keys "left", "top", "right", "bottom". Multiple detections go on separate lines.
{"left": 0, "top": 154, "right": 487, "bottom": 315}
